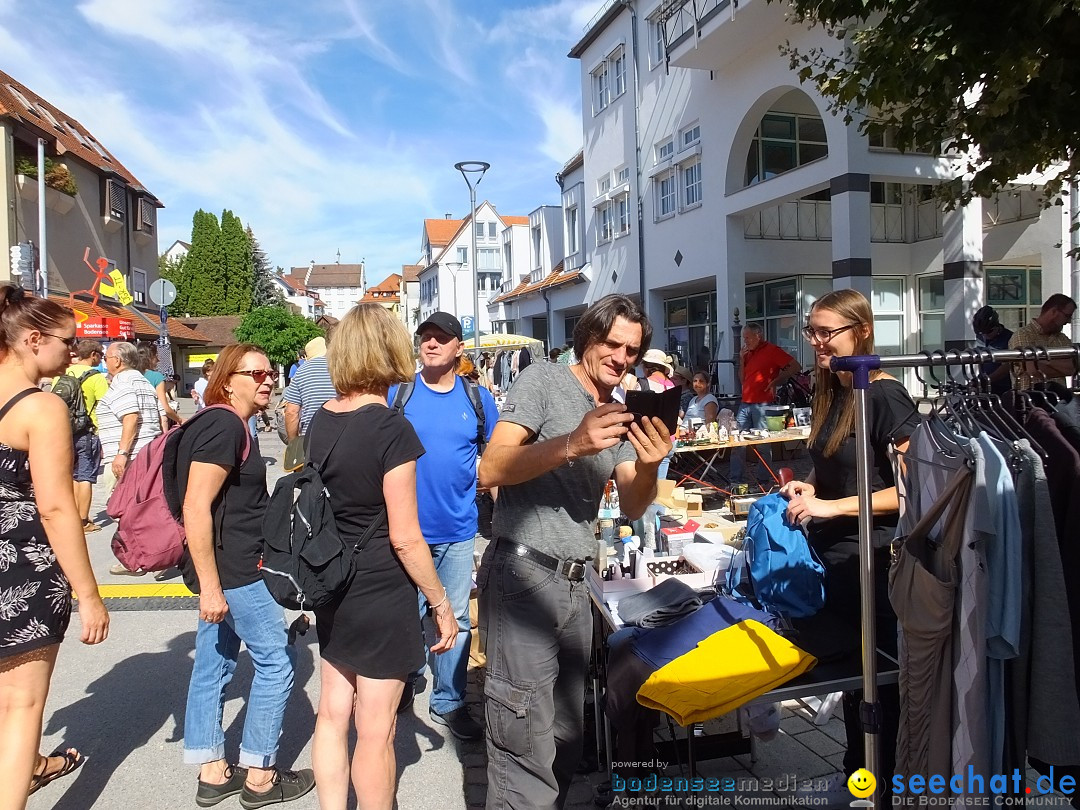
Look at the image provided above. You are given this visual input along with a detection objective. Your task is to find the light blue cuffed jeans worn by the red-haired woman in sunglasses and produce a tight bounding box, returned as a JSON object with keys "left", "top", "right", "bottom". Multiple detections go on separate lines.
{"left": 184, "top": 580, "right": 296, "bottom": 768}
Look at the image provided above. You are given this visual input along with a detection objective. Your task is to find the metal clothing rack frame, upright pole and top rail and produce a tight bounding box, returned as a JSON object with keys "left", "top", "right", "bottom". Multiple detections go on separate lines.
{"left": 829, "top": 343, "right": 1080, "bottom": 807}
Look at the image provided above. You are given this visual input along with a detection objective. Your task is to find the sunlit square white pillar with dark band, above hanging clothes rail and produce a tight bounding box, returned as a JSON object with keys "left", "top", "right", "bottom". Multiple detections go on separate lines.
{"left": 942, "top": 197, "right": 985, "bottom": 349}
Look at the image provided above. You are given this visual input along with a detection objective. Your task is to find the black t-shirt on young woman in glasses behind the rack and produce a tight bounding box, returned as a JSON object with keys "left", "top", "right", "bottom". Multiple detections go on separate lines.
{"left": 809, "top": 377, "right": 919, "bottom": 546}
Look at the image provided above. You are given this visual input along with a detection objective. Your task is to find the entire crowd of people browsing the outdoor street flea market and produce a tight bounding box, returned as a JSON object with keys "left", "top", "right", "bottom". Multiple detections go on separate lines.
{"left": 0, "top": 286, "right": 1075, "bottom": 809}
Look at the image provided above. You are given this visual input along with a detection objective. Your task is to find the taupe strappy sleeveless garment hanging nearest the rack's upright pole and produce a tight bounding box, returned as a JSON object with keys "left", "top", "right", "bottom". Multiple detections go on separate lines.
{"left": 889, "top": 453, "right": 972, "bottom": 774}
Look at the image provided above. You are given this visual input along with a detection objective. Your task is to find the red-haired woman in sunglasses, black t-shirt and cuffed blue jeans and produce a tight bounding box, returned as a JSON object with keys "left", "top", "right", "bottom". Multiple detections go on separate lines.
{"left": 176, "top": 343, "right": 314, "bottom": 807}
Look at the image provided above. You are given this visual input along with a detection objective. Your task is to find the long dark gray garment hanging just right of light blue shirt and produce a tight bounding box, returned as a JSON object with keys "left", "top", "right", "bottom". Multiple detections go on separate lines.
{"left": 1009, "top": 438, "right": 1080, "bottom": 767}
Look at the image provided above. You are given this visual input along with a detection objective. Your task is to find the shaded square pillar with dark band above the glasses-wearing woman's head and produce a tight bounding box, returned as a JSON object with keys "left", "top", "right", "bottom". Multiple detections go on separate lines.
{"left": 829, "top": 173, "right": 873, "bottom": 298}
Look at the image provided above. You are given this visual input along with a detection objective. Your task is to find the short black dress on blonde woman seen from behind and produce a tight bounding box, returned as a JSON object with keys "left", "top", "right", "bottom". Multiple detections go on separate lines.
{"left": 308, "top": 404, "right": 424, "bottom": 678}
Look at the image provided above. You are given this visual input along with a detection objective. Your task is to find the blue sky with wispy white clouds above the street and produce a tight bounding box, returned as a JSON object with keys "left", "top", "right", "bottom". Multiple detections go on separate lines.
{"left": 0, "top": 0, "right": 600, "bottom": 283}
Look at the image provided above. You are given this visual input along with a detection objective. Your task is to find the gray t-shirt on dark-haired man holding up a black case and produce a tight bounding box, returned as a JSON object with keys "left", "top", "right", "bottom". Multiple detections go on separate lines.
{"left": 492, "top": 363, "right": 637, "bottom": 559}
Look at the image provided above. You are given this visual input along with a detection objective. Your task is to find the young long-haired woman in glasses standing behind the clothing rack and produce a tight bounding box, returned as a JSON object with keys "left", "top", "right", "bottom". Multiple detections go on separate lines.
{"left": 781, "top": 289, "right": 918, "bottom": 786}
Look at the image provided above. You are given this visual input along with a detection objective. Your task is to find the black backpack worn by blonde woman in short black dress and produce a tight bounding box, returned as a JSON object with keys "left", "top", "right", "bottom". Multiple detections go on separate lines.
{"left": 259, "top": 414, "right": 387, "bottom": 610}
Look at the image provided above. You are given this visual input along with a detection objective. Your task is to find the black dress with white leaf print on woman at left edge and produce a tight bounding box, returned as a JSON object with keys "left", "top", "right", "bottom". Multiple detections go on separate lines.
{"left": 0, "top": 394, "right": 71, "bottom": 659}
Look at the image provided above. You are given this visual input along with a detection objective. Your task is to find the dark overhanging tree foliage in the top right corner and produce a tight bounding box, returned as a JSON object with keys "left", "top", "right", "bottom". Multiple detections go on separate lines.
{"left": 783, "top": 0, "right": 1080, "bottom": 204}
